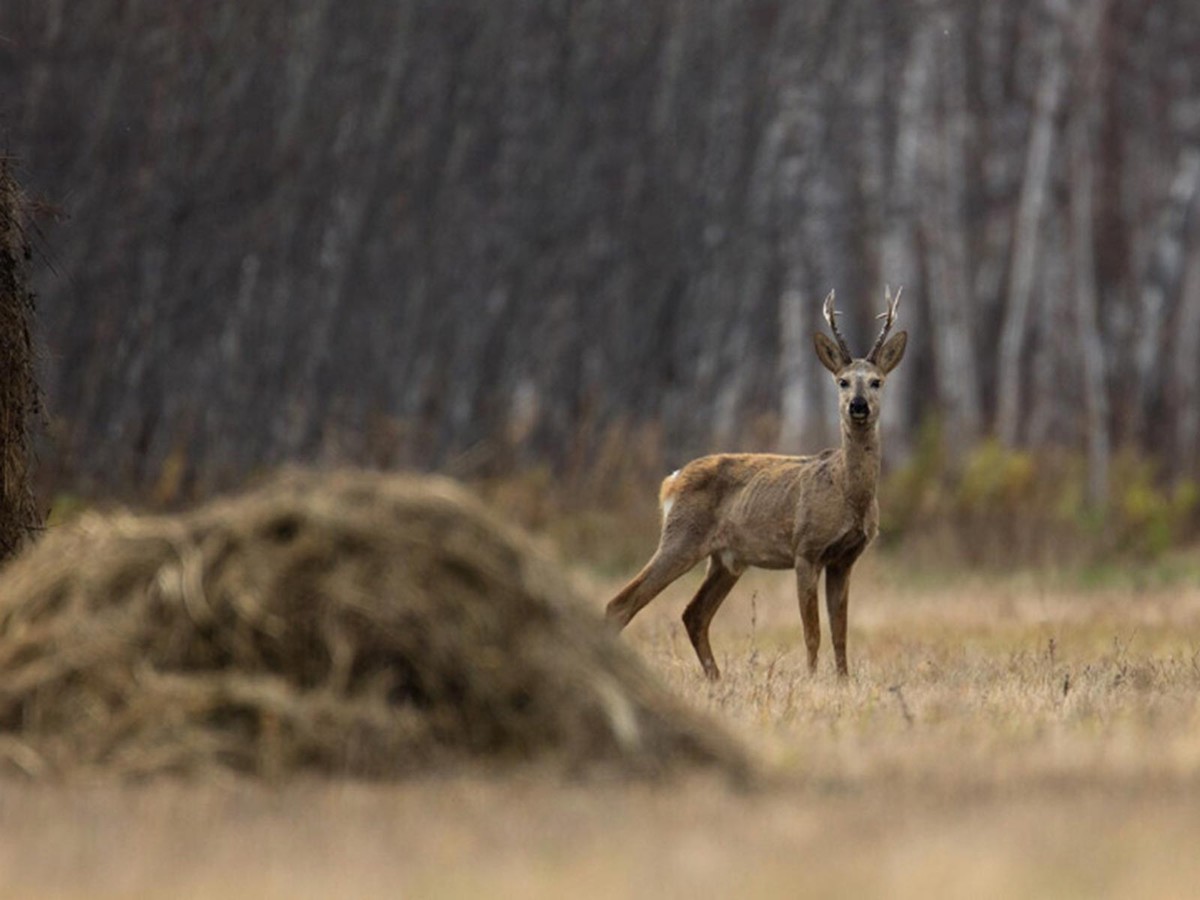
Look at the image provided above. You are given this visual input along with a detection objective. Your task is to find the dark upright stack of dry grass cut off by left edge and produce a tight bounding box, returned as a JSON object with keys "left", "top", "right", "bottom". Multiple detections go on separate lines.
{"left": 0, "top": 156, "right": 42, "bottom": 559}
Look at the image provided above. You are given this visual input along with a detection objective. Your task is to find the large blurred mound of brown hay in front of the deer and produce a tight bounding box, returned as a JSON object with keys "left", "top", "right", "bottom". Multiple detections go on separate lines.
{"left": 0, "top": 472, "right": 746, "bottom": 778}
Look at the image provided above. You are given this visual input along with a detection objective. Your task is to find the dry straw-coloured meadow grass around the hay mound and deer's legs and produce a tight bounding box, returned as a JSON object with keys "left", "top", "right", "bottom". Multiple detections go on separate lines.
{"left": 0, "top": 553, "right": 1200, "bottom": 898}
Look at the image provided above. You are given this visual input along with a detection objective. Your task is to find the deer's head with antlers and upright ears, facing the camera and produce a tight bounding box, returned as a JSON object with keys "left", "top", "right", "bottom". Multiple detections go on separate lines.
{"left": 812, "top": 288, "right": 908, "bottom": 428}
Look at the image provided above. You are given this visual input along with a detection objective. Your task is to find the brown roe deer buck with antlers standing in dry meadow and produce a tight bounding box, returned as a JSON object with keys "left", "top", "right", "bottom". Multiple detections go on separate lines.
{"left": 607, "top": 290, "right": 908, "bottom": 679}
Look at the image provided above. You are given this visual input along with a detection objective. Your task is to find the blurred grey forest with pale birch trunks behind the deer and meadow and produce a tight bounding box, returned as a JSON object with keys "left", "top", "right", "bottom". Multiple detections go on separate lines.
{"left": 0, "top": 0, "right": 1200, "bottom": 554}
